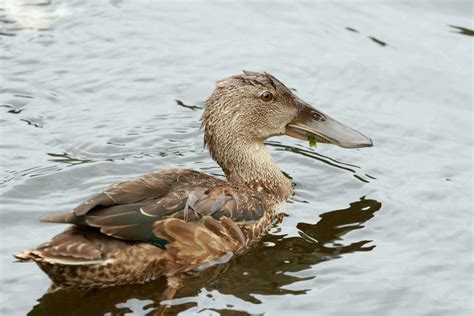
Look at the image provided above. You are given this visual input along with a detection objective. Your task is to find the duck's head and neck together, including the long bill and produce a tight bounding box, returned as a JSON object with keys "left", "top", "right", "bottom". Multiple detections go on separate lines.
{"left": 203, "top": 71, "right": 372, "bottom": 195}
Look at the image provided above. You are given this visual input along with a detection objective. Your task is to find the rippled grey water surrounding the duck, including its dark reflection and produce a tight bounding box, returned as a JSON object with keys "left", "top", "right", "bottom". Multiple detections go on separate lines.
{"left": 0, "top": 0, "right": 474, "bottom": 315}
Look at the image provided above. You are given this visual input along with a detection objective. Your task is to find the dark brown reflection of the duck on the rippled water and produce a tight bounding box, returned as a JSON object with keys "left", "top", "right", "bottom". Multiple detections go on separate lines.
{"left": 29, "top": 198, "right": 382, "bottom": 315}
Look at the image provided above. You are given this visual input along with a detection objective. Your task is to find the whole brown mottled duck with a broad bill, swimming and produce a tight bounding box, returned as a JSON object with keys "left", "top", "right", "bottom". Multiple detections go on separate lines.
{"left": 13, "top": 70, "right": 373, "bottom": 289}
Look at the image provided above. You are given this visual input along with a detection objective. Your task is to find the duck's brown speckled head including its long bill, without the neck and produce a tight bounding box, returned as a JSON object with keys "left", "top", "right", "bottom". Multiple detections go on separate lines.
{"left": 203, "top": 71, "right": 372, "bottom": 152}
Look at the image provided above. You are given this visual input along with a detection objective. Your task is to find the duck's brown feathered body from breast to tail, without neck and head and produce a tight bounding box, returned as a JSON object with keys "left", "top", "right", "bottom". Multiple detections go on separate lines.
{"left": 15, "top": 169, "right": 274, "bottom": 287}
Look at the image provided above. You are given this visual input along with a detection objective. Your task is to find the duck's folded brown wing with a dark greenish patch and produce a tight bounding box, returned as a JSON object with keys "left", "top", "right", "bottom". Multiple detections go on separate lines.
{"left": 41, "top": 169, "right": 264, "bottom": 246}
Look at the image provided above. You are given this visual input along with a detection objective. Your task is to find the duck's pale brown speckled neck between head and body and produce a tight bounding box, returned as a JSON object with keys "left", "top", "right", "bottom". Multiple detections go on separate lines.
{"left": 208, "top": 139, "right": 293, "bottom": 201}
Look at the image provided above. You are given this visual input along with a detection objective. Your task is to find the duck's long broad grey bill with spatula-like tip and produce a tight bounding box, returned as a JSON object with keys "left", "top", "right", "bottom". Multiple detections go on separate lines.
{"left": 285, "top": 100, "right": 373, "bottom": 148}
